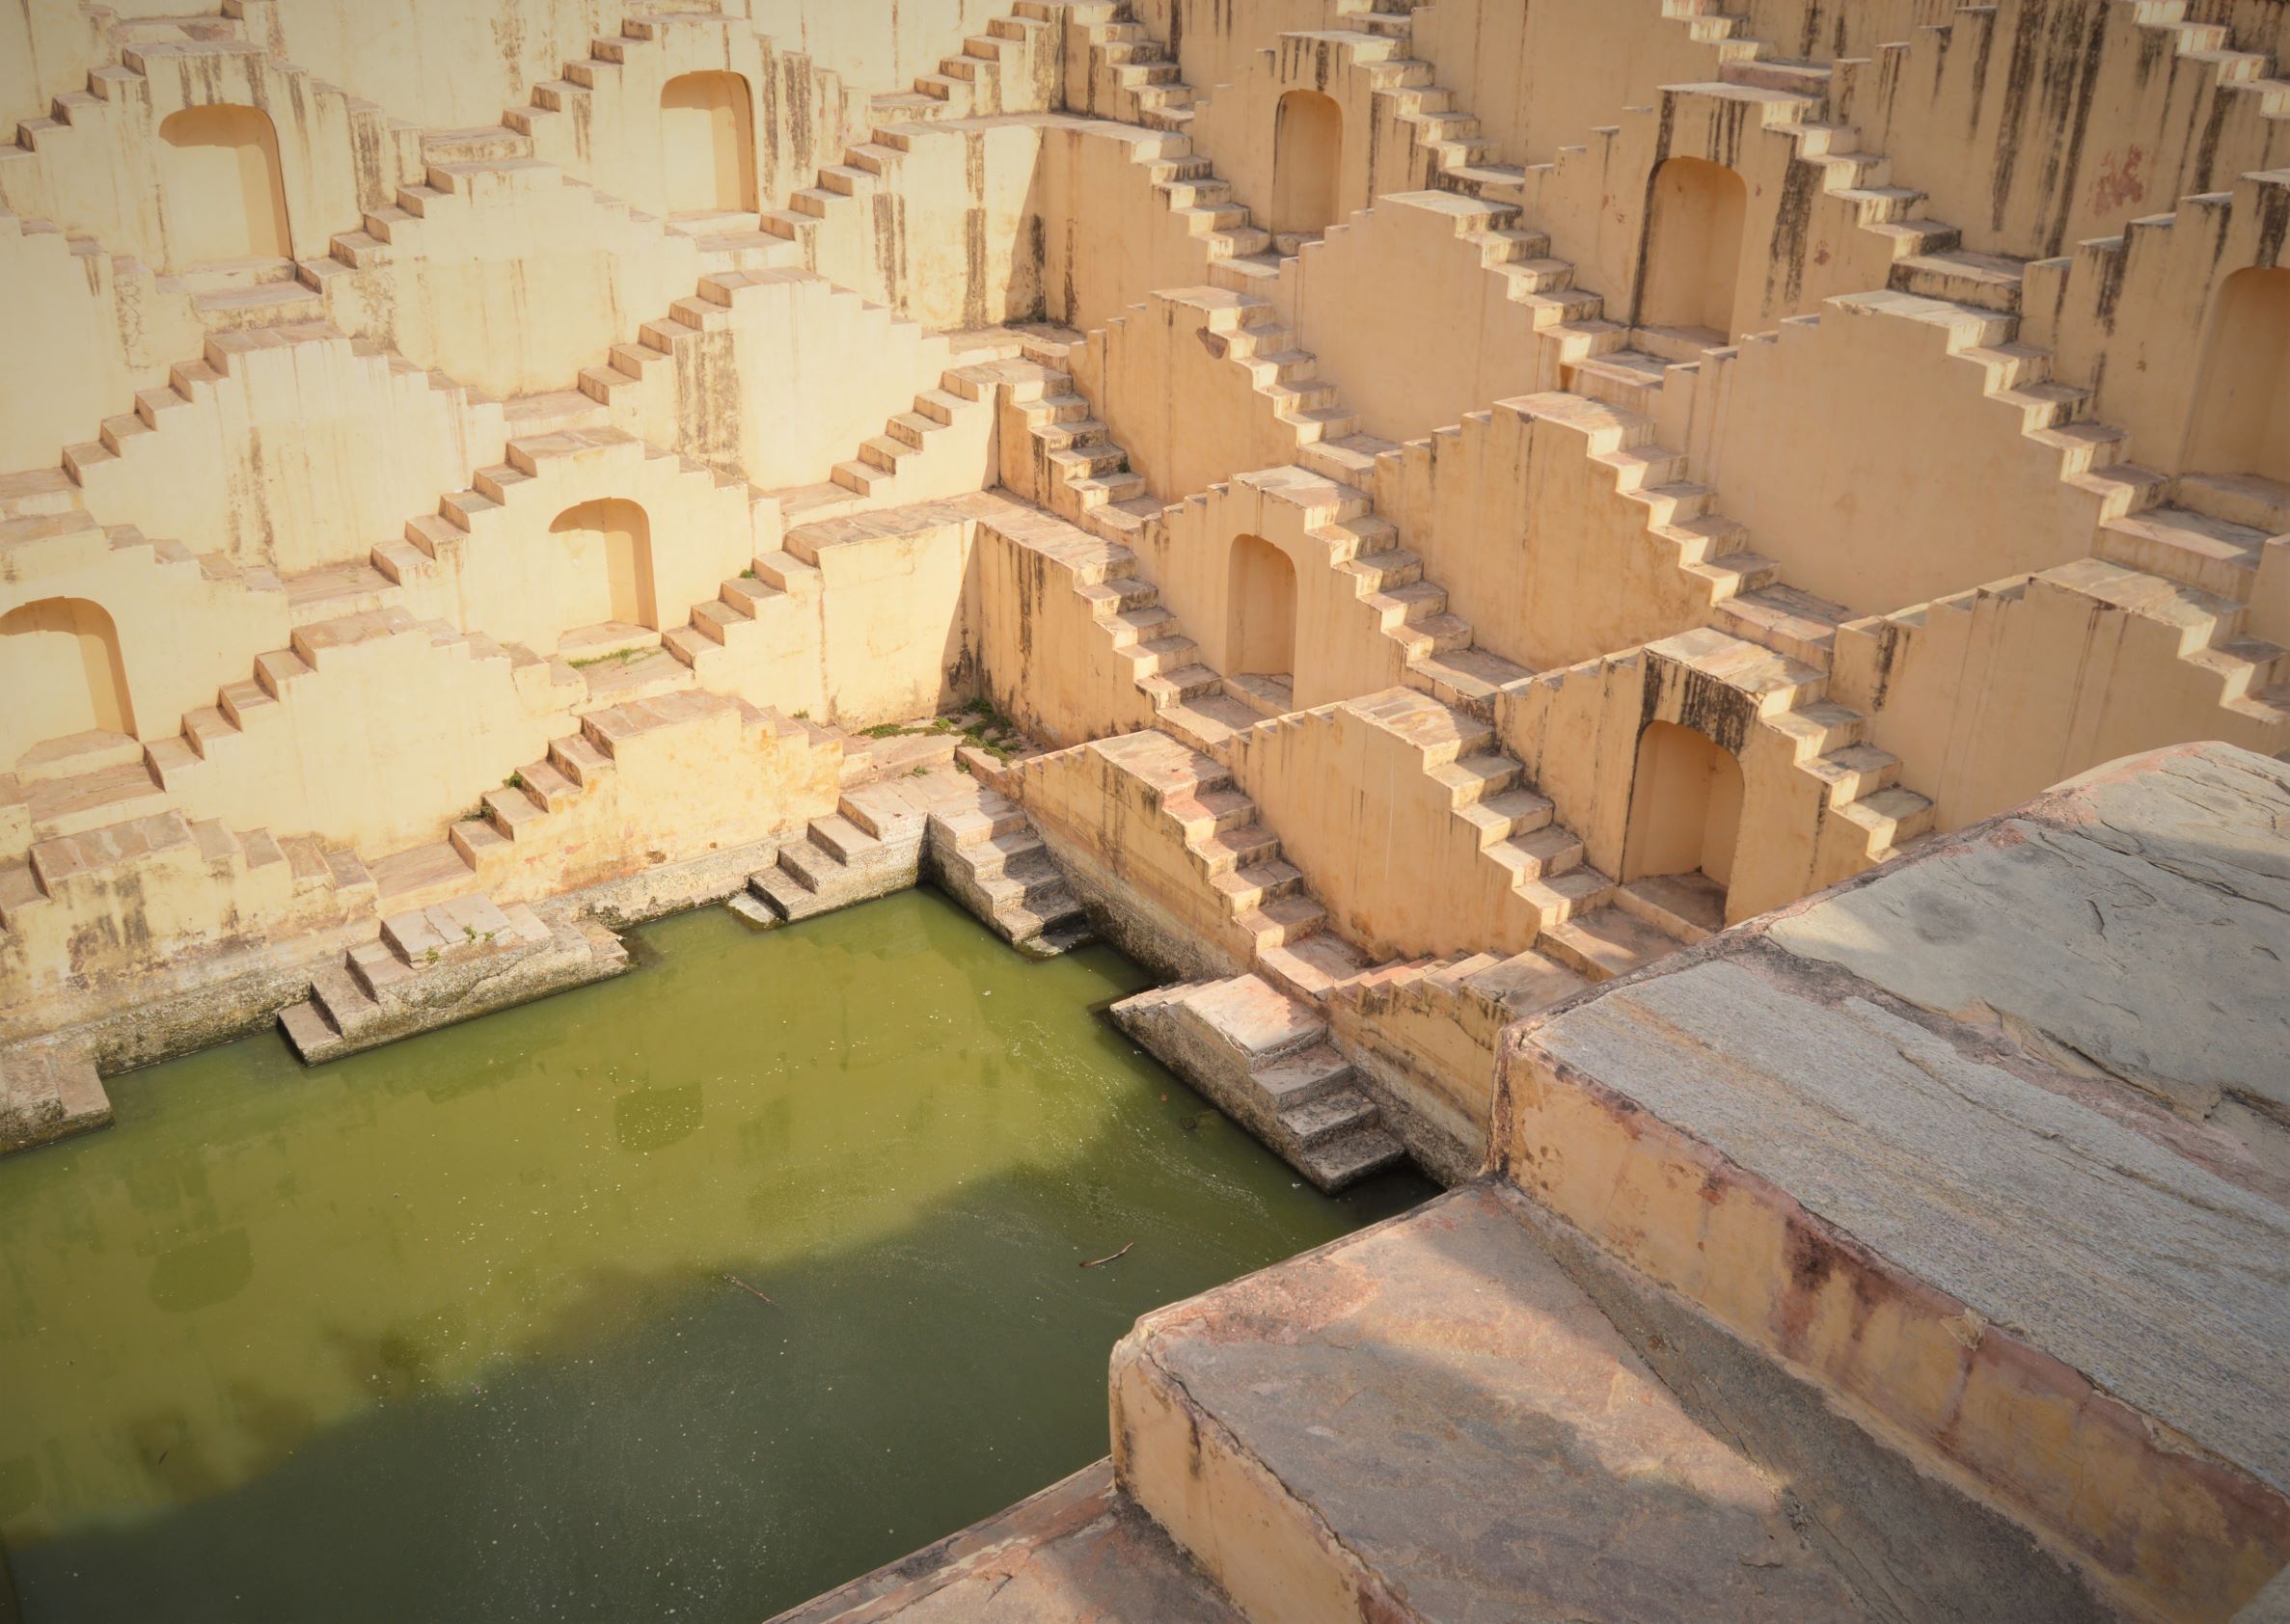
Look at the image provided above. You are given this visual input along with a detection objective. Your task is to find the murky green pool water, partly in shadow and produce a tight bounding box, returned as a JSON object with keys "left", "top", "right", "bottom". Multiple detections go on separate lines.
{"left": 0, "top": 891, "right": 1431, "bottom": 1624}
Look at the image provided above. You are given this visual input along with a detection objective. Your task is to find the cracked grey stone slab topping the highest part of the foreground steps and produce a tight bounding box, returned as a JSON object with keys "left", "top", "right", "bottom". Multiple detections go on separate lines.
{"left": 1768, "top": 746, "right": 2290, "bottom": 1123}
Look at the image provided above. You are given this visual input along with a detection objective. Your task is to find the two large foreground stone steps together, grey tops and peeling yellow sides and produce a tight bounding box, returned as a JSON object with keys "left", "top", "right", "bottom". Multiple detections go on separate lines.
{"left": 1085, "top": 751, "right": 2285, "bottom": 1624}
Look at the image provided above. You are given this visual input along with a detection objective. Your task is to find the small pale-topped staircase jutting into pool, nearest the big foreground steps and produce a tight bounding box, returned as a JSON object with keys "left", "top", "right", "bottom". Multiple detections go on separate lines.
{"left": 1108, "top": 976, "right": 1406, "bottom": 1193}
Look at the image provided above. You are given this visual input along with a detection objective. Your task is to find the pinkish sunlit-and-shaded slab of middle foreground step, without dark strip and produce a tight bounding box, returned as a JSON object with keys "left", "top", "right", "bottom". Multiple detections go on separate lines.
{"left": 1115, "top": 1184, "right": 1868, "bottom": 1624}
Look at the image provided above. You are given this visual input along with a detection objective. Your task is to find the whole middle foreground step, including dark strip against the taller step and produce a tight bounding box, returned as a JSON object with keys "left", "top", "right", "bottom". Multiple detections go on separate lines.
{"left": 1104, "top": 1182, "right": 2118, "bottom": 1624}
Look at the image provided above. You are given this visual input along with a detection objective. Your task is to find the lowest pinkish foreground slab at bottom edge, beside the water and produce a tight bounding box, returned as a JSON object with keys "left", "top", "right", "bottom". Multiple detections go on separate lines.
{"left": 772, "top": 1461, "right": 1243, "bottom": 1624}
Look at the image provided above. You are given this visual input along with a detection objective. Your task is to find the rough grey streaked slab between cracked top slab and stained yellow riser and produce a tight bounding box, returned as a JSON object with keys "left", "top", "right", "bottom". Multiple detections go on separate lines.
{"left": 1530, "top": 960, "right": 2290, "bottom": 1486}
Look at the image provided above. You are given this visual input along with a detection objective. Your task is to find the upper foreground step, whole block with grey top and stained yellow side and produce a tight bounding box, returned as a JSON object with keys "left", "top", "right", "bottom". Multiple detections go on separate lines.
{"left": 1495, "top": 744, "right": 2290, "bottom": 1617}
